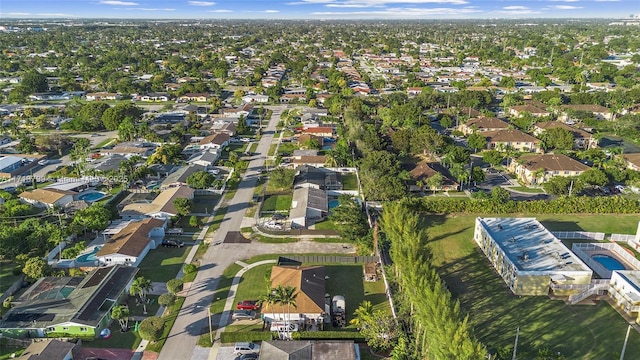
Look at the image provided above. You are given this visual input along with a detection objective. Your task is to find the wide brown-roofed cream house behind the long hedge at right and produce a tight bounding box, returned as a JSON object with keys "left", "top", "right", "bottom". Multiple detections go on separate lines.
{"left": 509, "top": 154, "right": 591, "bottom": 185}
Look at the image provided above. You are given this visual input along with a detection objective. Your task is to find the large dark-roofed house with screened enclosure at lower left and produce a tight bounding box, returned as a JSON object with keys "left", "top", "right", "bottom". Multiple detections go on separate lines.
{"left": 0, "top": 265, "right": 138, "bottom": 338}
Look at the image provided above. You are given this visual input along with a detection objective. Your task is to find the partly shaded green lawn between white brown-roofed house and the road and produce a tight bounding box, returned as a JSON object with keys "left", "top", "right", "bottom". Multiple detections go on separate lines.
{"left": 138, "top": 246, "right": 191, "bottom": 282}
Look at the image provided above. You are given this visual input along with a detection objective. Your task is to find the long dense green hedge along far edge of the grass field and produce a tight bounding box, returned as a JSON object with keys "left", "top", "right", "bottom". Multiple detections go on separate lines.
{"left": 409, "top": 196, "right": 640, "bottom": 214}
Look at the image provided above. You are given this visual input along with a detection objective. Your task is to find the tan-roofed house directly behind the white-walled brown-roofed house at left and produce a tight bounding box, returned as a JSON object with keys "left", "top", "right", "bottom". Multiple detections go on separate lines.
{"left": 120, "top": 186, "right": 194, "bottom": 220}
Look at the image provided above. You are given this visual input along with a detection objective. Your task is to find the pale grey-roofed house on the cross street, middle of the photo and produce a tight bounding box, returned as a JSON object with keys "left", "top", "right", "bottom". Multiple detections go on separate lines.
{"left": 289, "top": 187, "right": 329, "bottom": 228}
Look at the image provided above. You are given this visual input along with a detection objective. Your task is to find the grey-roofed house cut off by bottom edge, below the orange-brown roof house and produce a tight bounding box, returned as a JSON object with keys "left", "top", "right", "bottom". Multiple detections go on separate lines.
{"left": 260, "top": 340, "right": 360, "bottom": 360}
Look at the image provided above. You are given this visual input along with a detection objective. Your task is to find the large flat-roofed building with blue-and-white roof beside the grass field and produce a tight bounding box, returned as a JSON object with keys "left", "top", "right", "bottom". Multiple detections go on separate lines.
{"left": 474, "top": 218, "right": 592, "bottom": 296}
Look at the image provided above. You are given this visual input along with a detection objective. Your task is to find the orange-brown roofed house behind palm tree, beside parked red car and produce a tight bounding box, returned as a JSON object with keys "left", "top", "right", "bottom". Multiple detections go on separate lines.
{"left": 262, "top": 266, "right": 328, "bottom": 323}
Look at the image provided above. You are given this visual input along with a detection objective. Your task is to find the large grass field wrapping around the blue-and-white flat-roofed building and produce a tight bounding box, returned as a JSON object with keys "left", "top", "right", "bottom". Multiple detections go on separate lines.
{"left": 424, "top": 215, "right": 640, "bottom": 359}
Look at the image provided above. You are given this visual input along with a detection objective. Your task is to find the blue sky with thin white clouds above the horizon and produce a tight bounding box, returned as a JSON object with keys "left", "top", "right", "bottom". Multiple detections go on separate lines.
{"left": 0, "top": 0, "right": 640, "bottom": 22}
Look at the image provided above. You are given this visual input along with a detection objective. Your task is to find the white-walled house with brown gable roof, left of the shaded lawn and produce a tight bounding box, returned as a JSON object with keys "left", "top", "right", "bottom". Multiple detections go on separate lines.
{"left": 94, "top": 219, "right": 166, "bottom": 266}
